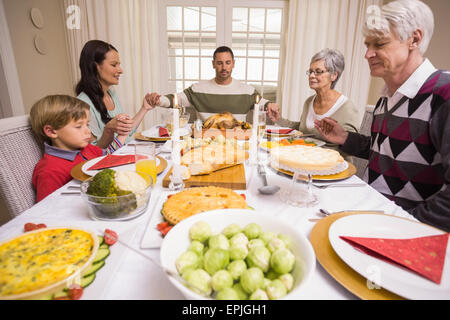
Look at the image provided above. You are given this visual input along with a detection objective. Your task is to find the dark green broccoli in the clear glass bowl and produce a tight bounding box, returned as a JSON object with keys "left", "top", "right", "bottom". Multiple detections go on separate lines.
{"left": 86, "top": 169, "right": 137, "bottom": 217}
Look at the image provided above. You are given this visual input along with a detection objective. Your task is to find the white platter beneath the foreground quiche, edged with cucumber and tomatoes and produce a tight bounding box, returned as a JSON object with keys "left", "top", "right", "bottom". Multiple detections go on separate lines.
{"left": 0, "top": 217, "right": 137, "bottom": 300}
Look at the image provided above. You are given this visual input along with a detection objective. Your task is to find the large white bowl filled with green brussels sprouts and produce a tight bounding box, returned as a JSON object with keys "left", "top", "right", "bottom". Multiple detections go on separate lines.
{"left": 160, "top": 209, "right": 316, "bottom": 300}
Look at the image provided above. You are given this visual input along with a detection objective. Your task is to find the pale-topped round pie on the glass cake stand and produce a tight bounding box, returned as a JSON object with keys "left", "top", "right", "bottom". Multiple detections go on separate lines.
{"left": 270, "top": 145, "right": 345, "bottom": 174}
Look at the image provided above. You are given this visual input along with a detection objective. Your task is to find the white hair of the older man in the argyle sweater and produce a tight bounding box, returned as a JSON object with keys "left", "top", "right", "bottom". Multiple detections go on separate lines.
{"left": 363, "top": 0, "right": 434, "bottom": 54}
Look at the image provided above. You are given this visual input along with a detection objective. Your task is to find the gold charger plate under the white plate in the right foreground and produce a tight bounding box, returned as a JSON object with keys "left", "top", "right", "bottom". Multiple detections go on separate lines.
{"left": 309, "top": 211, "right": 404, "bottom": 300}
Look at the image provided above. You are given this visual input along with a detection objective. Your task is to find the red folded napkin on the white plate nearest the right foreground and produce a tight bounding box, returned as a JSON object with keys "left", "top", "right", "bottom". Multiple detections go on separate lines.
{"left": 340, "top": 233, "right": 449, "bottom": 284}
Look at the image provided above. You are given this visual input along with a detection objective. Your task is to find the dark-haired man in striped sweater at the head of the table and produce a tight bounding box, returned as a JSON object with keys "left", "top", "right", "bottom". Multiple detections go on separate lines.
{"left": 150, "top": 46, "right": 279, "bottom": 121}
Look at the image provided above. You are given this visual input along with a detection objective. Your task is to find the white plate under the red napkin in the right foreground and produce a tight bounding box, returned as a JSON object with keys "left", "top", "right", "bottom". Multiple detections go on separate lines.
{"left": 328, "top": 214, "right": 450, "bottom": 300}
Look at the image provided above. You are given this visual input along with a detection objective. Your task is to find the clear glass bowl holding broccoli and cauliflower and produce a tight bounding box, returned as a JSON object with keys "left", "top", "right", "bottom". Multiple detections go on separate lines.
{"left": 81, "top": 169, "right": 153, "bottom": 221}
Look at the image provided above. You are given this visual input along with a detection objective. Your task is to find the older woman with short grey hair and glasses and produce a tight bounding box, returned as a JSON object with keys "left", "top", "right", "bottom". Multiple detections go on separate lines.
{"left": 276, "top": 49, "right": 360, "bottom": 156}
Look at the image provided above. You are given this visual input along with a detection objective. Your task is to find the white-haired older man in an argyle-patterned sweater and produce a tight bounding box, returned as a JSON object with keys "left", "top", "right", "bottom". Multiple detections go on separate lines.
{"left": 316, "top": 0, "right": 450, "bottom": 231}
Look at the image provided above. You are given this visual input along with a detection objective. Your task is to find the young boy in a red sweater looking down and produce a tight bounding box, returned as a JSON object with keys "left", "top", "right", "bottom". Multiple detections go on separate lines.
{"left": 30, "top": 95, "right": 106, "bottom": 202}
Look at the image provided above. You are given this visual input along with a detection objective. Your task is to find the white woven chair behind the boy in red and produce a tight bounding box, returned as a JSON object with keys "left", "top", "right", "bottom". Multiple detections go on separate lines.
{"left": 0, "top": 115, "right": 42, "bottom": 220}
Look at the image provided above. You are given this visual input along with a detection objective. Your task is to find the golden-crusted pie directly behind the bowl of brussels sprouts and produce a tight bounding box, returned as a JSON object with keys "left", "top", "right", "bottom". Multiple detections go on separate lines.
{"left": 161, "top": 186, "right": 248, "bottom": 224}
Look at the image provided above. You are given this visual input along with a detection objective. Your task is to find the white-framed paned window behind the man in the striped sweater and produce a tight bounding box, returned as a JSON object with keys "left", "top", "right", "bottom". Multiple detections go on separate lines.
{"left": 160, "top": 0, "right": 287, "bottom": 101}
